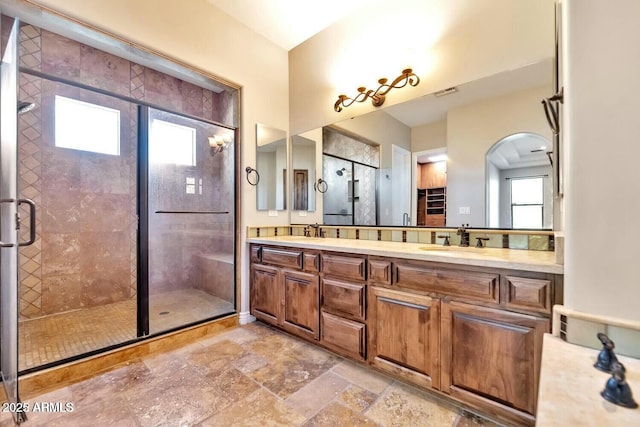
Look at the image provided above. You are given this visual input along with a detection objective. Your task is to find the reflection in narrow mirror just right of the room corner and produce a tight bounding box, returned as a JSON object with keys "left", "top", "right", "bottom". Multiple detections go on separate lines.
{"left": 291, "top": 135, "right": 316, "bottom": 212}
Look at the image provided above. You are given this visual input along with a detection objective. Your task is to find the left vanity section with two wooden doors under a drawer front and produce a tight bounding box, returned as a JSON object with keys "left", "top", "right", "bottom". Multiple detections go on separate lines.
{"left": 250, "top": 246, "right": 320, "bottom": 340}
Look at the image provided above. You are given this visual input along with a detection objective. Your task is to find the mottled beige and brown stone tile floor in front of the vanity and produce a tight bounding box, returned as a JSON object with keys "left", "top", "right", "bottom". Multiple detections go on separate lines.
{"left": 0, "top": 322, "right": 495, "bottom": 427}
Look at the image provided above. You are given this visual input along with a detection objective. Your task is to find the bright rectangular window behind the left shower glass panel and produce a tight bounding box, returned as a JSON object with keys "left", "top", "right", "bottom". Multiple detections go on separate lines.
{"left": 55, "top": 95, "right": 120, "bottom": 156}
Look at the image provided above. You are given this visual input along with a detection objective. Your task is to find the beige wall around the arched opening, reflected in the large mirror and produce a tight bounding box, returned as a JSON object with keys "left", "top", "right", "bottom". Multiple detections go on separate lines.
{"left": 447, "top": 86, "right": 551, "bottom": 227}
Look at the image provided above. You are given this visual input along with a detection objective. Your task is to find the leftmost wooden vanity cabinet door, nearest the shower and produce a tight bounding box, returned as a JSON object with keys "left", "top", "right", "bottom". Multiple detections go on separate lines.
{"left": 250, "top": 264, "right": 282, "bottom": 325}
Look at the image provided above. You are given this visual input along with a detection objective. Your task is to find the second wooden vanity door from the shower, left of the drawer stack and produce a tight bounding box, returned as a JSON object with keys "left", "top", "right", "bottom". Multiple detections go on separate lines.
{"left": 282, "top": 270, "right": 320, "bottom": 340}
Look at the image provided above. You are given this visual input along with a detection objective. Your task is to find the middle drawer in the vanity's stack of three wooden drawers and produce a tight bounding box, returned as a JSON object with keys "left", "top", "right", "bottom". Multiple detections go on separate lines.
{"left": 322, "top": 279, "right": 365, "bottom": 321}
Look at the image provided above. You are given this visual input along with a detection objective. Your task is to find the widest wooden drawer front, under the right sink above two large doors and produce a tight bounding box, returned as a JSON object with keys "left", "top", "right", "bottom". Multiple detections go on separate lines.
{"left": 393, "top": 261, "right": 500, "bottom": 304}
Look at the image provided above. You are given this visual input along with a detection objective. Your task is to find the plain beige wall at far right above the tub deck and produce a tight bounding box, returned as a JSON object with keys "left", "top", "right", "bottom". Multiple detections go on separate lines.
{"left": 563, "top": 0, "right": 640, "bottom": 326}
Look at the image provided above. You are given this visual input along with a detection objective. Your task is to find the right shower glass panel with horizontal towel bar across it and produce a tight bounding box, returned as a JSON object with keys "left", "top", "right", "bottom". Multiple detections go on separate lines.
{"left": 147, "top": 108, "right": 235, "bottom": 334}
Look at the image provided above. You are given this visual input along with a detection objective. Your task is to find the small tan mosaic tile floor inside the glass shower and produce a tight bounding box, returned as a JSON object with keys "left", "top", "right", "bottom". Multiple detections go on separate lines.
{"left": 18, "top": 289, "right": 234, "bottom": 371}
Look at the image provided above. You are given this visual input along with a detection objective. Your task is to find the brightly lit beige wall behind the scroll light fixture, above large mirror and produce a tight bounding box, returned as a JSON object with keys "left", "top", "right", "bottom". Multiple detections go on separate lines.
{"left": 289, "top": 0, "right": 554, "bottom": 135}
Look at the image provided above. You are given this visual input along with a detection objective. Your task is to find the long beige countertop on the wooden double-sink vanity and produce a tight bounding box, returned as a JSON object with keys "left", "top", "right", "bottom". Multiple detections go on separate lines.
{"left": 247, "top": 236, "right": 564, "bottom": 274}
